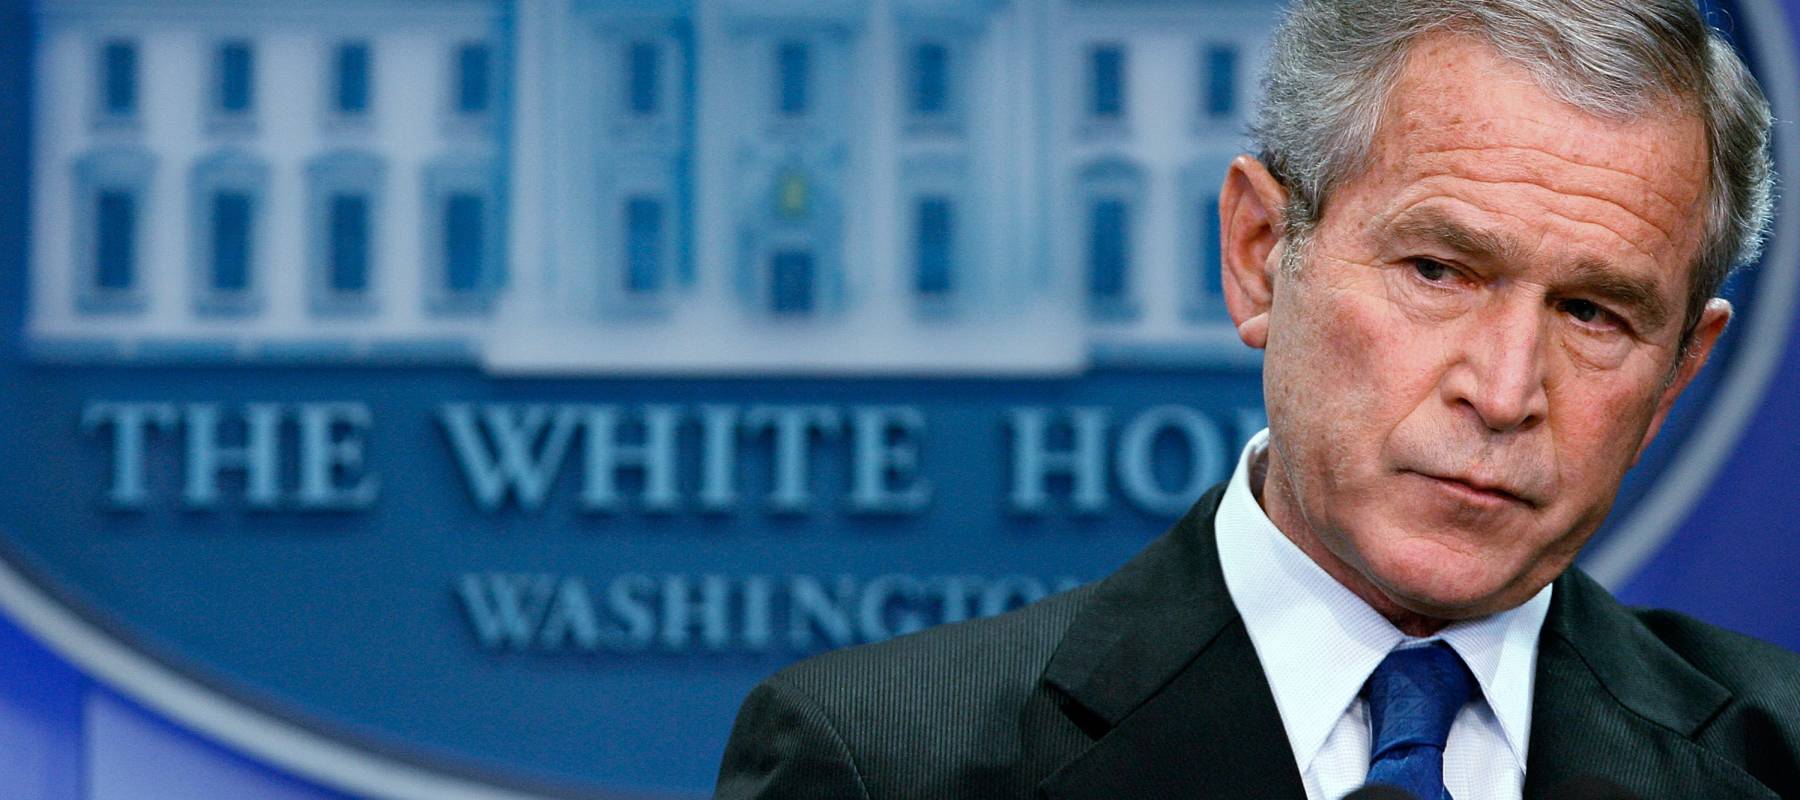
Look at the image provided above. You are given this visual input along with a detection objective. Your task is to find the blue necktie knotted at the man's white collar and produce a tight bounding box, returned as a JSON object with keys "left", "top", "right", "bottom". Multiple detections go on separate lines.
{"left": 1363, "top": 641, "right": 1476, "bottom": 800}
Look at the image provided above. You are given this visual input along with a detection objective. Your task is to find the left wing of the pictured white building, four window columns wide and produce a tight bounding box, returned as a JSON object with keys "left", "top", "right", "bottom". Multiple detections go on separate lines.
{"left": 27, "top": 0, "right": 504, "bottom": 360}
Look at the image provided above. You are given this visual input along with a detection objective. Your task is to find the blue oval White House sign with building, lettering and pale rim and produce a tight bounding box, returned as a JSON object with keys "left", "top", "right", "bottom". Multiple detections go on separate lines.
{"left": 0, "top": 0, "right": 1800, "bottom": 798}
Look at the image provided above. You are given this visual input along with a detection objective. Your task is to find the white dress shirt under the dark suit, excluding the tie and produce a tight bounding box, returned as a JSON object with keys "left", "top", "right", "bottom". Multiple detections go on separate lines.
{"left": 1213, "top": 431, "right": 1550, "bottom": 800}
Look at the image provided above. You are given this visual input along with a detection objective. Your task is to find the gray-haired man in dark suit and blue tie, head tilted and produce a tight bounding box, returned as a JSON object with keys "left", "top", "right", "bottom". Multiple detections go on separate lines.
{"left": 718, "top": 0, "right": 1800, "bottom": 800}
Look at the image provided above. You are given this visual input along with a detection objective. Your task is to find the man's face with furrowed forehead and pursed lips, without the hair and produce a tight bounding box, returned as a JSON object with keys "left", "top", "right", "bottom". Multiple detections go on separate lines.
{"left": 1240, "top": 34, "right": 1730, "bottom": 620}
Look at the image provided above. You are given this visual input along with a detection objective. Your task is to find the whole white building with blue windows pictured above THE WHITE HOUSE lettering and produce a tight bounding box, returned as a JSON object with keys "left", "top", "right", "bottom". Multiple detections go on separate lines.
{"left": 25, "top": 0, "right": 1274, "bottom": 375}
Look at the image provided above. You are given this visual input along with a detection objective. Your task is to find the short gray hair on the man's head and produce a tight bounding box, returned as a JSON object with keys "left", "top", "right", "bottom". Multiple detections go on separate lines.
{"left": 1251, "top": 0, "right": 1775, "bottom": 348}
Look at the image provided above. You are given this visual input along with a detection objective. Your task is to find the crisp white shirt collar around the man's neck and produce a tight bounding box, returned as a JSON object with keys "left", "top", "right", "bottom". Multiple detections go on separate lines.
{"left": 1213, "top": 429, "right": 1552, "bottom": 771}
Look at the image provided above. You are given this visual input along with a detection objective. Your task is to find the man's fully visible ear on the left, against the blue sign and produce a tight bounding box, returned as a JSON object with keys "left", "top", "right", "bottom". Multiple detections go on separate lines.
{"left": 1219, "top": 155, "right": 1287, "bottom": 350}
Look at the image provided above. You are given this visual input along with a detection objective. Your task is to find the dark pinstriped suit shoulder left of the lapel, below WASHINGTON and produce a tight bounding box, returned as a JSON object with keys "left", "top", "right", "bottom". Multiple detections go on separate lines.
{"left": 720, "top": 587, "right": 1093, "bottom": 798}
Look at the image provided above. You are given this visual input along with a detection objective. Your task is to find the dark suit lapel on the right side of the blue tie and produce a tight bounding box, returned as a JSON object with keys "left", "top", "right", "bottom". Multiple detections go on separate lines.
{"left": 1525, "top": 569, "right": 1775, "bottom": 800}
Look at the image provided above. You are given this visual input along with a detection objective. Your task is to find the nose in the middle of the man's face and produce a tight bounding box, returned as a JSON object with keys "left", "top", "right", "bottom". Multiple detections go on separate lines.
{"left": 1442, "top": 308, "right": 1550, "bottom": 432}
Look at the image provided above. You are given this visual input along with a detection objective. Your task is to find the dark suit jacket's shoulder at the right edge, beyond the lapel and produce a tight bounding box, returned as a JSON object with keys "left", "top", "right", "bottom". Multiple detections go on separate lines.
{"left": 1633, "top": 609, "right": 1800, "bottom": 709}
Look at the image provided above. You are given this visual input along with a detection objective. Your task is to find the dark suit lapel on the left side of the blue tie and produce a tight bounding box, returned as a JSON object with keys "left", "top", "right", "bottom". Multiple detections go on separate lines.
{"left": 1039, "top": 486, "right": 1305, "bottom": 800}
